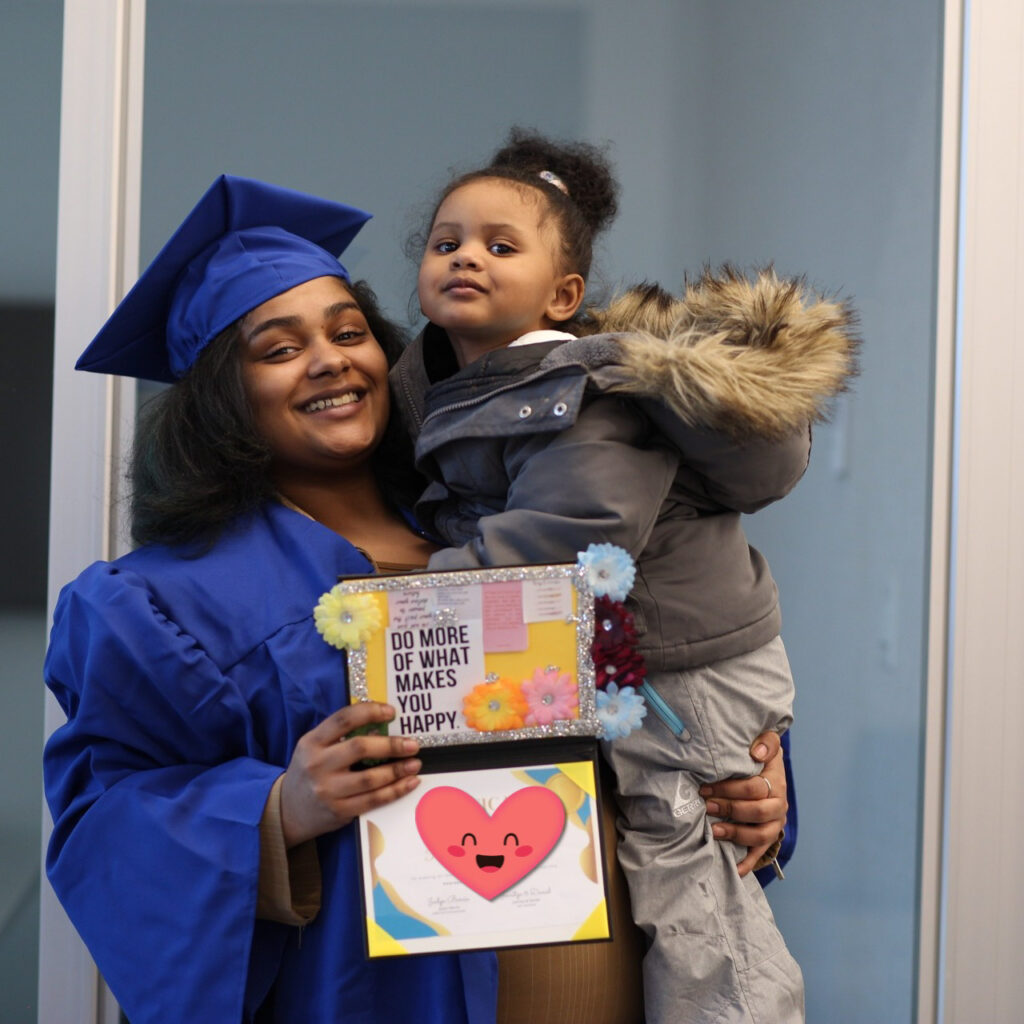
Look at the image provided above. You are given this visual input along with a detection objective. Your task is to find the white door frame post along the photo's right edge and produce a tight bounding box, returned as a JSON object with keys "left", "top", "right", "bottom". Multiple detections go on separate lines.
{"left": 925, "top": 0, "right": 1024, "bottom": 1024}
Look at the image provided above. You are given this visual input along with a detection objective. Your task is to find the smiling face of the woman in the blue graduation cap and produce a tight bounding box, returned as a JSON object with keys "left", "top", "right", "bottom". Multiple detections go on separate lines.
{"left": 241, "top": 278, "right": 389, "bottom": 478}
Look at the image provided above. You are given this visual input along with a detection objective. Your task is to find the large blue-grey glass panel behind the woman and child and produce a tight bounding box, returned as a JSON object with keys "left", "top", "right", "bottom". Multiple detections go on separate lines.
{"left": 132, "top": 0, "right": 942, "bottom": 1024}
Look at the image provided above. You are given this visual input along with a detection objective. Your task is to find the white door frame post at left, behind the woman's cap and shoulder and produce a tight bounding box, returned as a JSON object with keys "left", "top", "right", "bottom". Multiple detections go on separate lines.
{"left": 38, "top": 0, "right": 145, "bottom": 1024}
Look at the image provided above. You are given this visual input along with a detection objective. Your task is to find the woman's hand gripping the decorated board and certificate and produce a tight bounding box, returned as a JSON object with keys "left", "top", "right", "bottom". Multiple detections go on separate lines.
{"left": 281, "top": 700, "right": 422, "bottom": 847}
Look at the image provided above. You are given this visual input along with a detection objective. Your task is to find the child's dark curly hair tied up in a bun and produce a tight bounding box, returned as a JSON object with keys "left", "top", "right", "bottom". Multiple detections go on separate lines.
{"left": 408, "top": 128, "right": 618, "bottom": 290}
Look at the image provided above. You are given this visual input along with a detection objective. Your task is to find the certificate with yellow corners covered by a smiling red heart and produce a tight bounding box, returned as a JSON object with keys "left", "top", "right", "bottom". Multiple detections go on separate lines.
{"left": 357, "top": 740, "right": 610, "bottom": 957}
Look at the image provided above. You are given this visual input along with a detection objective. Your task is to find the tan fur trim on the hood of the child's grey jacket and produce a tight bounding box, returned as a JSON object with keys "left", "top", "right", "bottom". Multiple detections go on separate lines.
{"left": 544, "top": 266, "right": 859, "bottom": 439}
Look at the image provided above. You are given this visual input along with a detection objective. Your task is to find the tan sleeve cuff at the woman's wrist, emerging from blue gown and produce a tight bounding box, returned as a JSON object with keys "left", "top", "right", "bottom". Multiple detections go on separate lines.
{"left": 256, "top": 775, "right": 322, "bottom": 925}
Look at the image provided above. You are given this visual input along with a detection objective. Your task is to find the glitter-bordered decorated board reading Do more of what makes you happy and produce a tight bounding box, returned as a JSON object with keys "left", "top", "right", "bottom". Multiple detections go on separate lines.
{"left": 332, "top": 564, "right": 599, "bottom": 746}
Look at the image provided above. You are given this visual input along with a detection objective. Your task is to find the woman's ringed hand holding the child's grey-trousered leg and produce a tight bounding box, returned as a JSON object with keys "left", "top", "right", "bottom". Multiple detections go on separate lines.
{"left": 700, "top": 732, "right": 790, "bottom": 876}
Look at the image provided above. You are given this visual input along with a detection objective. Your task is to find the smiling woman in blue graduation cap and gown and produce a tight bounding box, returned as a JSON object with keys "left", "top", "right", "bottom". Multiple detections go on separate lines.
{"left": 44, "top": 177, "right": 784, "bottom": 1024}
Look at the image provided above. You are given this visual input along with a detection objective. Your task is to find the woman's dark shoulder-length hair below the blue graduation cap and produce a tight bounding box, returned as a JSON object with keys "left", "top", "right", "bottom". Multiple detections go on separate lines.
{"left": 129, "top": 281, "right": 420, "bottom": 547}
